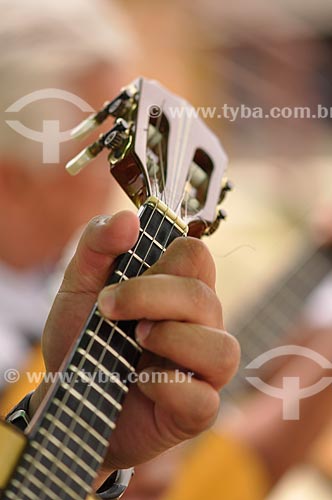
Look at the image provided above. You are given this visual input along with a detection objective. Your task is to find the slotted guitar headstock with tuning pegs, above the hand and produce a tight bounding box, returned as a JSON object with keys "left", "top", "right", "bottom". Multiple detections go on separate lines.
{"left": 66, "top": 78, "right": 231, "bottom": 237}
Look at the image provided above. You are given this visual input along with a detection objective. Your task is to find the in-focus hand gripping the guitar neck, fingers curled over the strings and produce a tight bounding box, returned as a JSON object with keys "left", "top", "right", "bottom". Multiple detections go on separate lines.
{"left": 30, "top": 212, "right": 239, "bottom": 484}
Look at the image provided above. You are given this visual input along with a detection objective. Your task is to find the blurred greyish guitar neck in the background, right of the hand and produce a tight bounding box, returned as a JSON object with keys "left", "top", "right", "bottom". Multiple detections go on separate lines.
{"left": 225, "top": 243, "right": 332, "bottom": 397}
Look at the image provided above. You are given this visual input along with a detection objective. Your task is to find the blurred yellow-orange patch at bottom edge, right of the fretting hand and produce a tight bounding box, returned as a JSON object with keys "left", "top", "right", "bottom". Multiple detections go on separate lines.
{"left": 163, "top": 432, "right": 269, "bottom": 500}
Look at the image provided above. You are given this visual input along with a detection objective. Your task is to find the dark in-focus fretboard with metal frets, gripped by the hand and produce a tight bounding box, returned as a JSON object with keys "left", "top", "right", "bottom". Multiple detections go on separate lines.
{"left": 4, "top": 199, "right": 185, "bottom": 500}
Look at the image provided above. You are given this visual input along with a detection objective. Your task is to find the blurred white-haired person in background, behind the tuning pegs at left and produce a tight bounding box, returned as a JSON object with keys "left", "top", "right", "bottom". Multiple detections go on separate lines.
{"left": 0, "top": 0, "right": 131, "bottom": 409}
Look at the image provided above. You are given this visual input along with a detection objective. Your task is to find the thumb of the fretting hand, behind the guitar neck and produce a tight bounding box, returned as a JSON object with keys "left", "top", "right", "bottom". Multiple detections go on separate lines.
{"left": 42, "top": 212, "right": 139, "bottom": 371}
